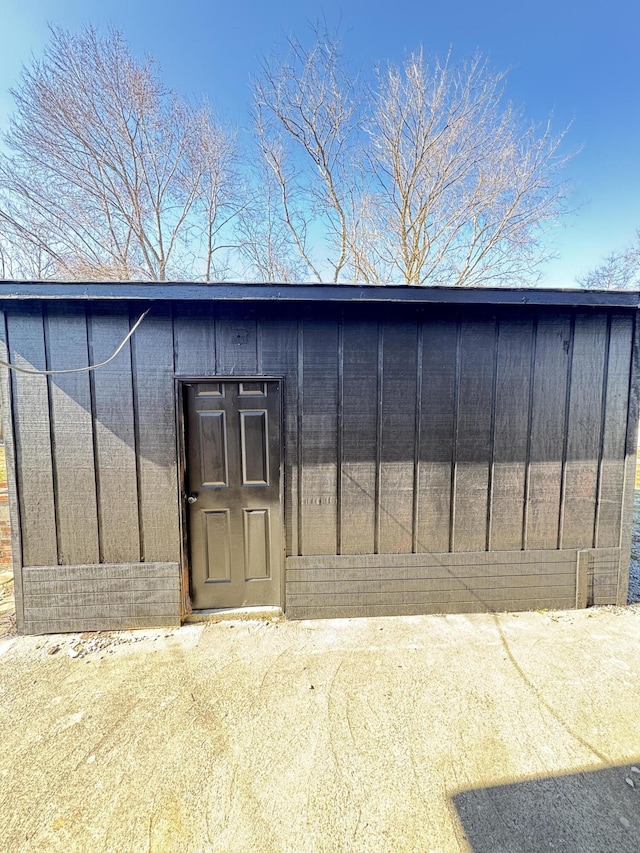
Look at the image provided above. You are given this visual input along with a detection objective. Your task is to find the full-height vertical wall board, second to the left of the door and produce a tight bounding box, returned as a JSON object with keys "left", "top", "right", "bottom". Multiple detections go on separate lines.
{"left": 89, "top": 308, "right": 141, "bottom": 563}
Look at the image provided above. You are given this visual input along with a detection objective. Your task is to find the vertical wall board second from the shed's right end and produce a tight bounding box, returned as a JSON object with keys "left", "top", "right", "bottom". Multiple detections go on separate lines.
{"left": 558, "top": 313, "right": 607, "bottom": 548}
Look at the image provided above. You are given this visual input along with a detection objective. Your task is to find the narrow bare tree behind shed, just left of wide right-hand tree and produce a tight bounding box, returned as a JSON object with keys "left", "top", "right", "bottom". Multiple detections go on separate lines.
{"left": 254, "top": 29, "right": 359, "bottom": 282}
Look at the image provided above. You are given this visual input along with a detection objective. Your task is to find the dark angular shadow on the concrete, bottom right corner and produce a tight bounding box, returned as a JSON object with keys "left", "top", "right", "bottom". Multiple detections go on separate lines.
{"left": 452, "top": 758, "right": 640, "bottom": 853}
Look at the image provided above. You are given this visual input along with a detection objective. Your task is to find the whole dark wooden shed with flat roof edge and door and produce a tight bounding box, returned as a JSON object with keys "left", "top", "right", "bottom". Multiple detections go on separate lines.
{"left": 0, "top": 282, "right": 638, "bottom": 633}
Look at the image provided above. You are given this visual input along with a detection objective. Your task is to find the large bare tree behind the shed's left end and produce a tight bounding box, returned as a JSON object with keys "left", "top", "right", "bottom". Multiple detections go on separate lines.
{"left": 0, "top": 27, "right": 237, "bottom": 281}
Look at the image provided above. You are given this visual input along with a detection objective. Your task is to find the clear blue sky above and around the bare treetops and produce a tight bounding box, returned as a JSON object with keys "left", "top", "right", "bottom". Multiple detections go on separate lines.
{"left": 0, "top": 0, "right": 640, "bottom": 287}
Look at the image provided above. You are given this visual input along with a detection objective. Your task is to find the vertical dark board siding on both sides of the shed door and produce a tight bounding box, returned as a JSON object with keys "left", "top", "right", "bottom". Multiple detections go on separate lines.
{"left": 6, "top": 304, "right": 633, "bottom": 572}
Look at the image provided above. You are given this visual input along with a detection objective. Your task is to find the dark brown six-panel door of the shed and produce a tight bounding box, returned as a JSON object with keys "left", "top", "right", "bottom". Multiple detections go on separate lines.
{"left": 185, "top": 380, "right": 282, "bottom": 610}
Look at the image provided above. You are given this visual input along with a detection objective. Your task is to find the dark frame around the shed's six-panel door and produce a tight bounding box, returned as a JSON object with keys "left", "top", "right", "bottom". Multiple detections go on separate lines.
{"left": 174, "top": 373, "right": 287, "bottom": 619}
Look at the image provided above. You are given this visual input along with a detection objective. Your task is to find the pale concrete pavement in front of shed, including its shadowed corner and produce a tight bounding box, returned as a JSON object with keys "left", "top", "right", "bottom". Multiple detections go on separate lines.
{"left": 0, "top": 606, "right": 640, "bottom": 853}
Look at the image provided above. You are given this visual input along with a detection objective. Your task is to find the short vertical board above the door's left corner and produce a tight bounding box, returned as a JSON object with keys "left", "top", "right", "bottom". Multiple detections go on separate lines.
{"left": 173, "top": 303, "right": 216, "bottom": 377}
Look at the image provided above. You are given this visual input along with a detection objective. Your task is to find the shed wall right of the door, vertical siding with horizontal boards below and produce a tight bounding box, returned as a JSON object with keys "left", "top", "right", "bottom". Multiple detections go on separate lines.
{"left": 287, "top": 308, "right": 637, "bottom": 618}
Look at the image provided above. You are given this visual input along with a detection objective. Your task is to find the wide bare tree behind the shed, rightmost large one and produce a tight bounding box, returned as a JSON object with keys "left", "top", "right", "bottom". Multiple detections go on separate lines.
{"left": 360, "top": 51, "right": 564, "bottom": 286}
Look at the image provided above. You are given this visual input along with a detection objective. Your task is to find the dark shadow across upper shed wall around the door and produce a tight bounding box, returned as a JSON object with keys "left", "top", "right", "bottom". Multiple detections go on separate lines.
{"left": 8, "top": 304, "right": 632, "bottom": 466}
